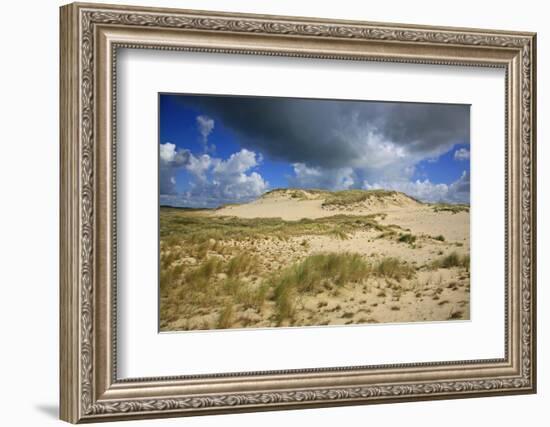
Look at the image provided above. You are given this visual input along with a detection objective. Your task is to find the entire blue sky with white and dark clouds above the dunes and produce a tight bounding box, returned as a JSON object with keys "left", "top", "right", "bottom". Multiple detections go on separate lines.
{"left": 159, "top": 94, "right": 470, "bottom": 208}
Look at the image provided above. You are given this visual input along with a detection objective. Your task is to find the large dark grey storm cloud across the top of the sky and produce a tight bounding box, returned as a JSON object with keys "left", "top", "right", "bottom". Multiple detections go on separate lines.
{"left": 172, "top": 96, "right": 470, "bottom": 169}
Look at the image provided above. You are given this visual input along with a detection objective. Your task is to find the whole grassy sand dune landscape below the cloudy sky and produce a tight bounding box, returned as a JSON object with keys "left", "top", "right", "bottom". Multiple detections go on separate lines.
{"left": 161, "top": 189, "right": 470, "bottom": 330}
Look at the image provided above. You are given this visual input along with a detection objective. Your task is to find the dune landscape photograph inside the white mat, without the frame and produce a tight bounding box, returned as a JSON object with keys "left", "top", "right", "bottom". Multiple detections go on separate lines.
{"left": 158, "top": 93, "right": 470, "bottom": 332}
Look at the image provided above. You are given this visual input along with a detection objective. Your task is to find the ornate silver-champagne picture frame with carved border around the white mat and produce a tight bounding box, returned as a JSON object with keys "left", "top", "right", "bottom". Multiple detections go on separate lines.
{"left": 60, "top": 4, "right": 536, "bottom": 423}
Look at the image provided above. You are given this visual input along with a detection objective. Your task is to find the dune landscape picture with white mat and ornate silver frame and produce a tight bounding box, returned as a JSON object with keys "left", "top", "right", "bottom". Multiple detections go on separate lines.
{"left": 60, "top": 4, "right": 536, "bottom": 423}
